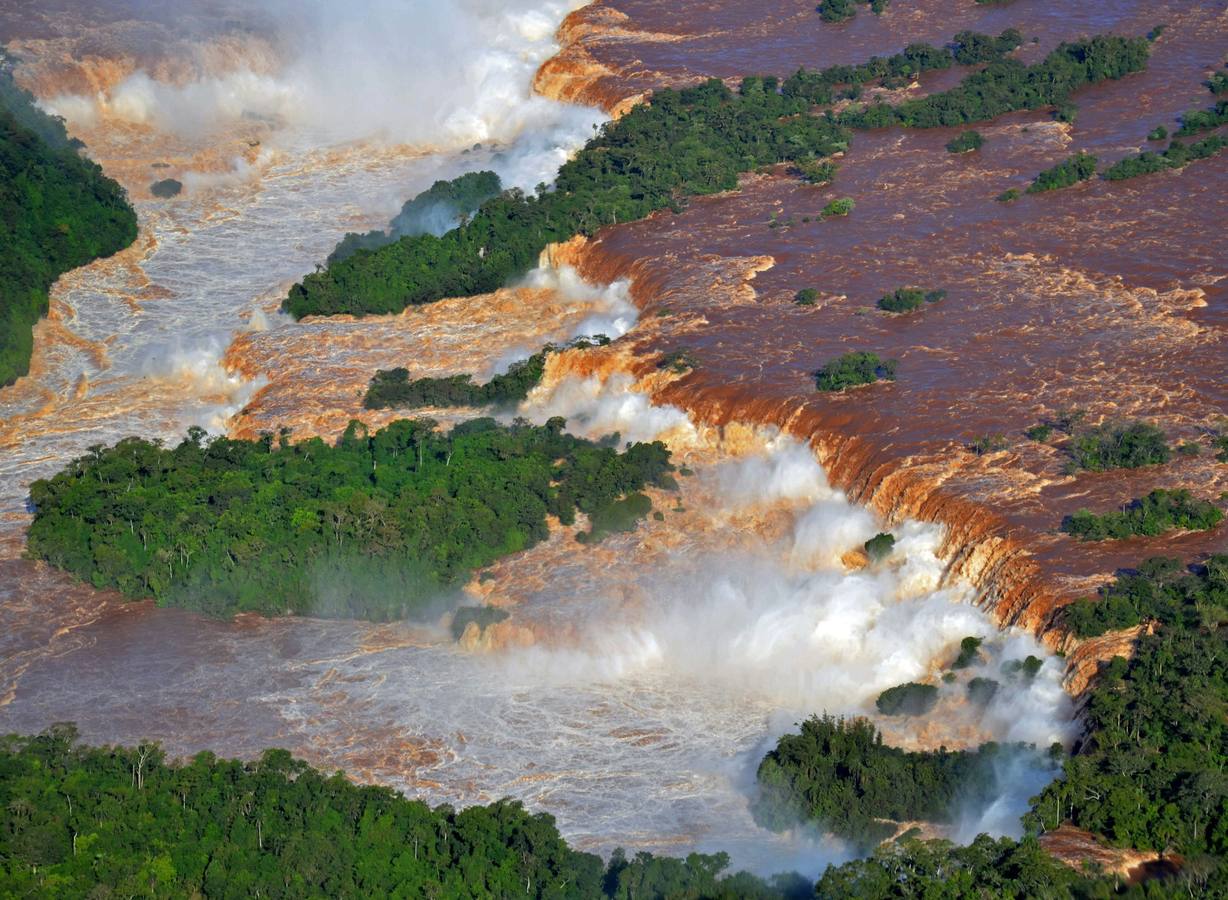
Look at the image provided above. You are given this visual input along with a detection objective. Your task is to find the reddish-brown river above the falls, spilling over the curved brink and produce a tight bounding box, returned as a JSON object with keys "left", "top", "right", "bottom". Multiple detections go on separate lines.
{"left": 538, "top": 0, "right": 1228, "bottom": 642}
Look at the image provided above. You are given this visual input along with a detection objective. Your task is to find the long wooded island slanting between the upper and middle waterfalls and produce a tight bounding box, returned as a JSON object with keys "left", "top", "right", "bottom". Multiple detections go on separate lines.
{"left": 285, "top": 79, "right": 847, "bottom": 318}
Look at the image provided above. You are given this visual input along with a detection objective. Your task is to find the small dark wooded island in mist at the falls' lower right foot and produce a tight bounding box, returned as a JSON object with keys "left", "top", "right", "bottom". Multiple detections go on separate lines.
{"left": 754, "top": 716, "right": 1021, "bottom": 850}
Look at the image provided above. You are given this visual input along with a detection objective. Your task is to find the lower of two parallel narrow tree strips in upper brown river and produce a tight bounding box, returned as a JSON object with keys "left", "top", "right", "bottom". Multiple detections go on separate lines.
{"left": 837, "top": 32, "right": 1149, "bottom": 128}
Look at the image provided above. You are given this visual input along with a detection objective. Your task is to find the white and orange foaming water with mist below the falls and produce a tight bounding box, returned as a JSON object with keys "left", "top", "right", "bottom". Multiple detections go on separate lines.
{"left": 0, "top": 2, "right": 1068, "bottom": 871}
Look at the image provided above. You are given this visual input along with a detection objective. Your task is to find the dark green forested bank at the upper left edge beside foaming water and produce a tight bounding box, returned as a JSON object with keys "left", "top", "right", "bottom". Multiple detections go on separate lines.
{"left": 0, "top": 63, "right": 136, "bottom": 387}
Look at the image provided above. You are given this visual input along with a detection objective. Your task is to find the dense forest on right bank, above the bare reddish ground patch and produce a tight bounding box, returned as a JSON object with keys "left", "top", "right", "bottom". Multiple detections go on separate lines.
{"left": 1029, "top": 556, "right": 1228, "bottom": 854}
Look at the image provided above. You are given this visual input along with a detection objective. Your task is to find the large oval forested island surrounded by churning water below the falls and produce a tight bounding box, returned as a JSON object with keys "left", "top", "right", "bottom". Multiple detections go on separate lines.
{"left": 28, "top": 419, "right": 674, "bottom": 620}
